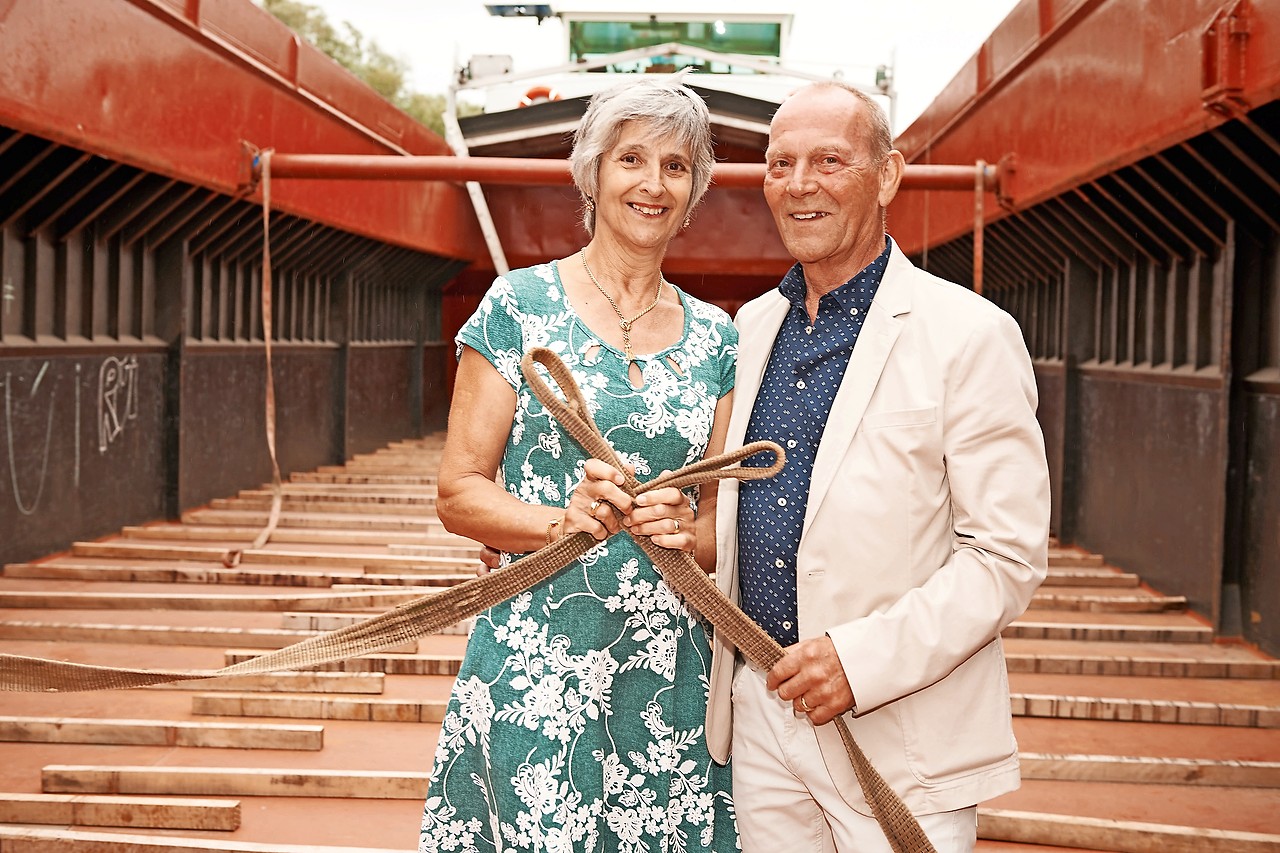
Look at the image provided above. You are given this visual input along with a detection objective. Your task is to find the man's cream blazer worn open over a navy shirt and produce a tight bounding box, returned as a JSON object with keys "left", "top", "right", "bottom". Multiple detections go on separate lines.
{"left": 707, "top": 245, "right": 1050, "bottom": 815}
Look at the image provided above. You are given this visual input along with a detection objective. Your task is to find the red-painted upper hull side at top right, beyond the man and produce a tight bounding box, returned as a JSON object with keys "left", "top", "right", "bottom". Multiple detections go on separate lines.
{"left": 892, "top": 0, "right": 1280, "bottom": 252}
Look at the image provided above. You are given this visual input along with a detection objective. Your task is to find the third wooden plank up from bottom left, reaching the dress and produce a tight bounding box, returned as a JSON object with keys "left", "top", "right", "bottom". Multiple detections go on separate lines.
{"left": 41, "top": 765, "right": 430, "bottom": 799}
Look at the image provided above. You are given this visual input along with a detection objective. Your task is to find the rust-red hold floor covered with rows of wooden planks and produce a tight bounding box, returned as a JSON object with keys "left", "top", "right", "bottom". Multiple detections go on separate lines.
{"left": 0, "top": 435, "right": 1280, "bottom": 853}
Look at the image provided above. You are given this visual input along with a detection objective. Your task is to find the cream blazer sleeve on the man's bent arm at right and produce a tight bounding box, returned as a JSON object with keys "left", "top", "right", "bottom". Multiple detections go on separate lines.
{"left": 827, "top": 310, "right": 1050, "bottom": 713}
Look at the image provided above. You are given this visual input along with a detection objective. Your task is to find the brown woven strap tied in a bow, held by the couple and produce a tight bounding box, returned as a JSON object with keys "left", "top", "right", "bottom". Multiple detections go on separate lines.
{"left": 0, "top": 348, "right": 936, "bottom": 853}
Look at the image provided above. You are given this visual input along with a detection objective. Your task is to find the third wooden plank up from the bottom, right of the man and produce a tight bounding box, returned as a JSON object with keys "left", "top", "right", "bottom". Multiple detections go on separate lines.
{"left": 1010, "top": 693, "right": 1280, "bottom": 729}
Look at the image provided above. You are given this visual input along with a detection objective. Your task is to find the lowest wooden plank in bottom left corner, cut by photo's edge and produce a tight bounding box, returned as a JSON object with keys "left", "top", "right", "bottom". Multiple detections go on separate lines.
{"left": 0, "top": 826, "right": 407, "bottom": 853}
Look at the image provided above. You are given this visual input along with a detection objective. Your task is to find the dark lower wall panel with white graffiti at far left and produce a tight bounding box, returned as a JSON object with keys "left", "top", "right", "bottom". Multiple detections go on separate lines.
{"left": 0, "top": 348, "right": 169, "bottom": 565}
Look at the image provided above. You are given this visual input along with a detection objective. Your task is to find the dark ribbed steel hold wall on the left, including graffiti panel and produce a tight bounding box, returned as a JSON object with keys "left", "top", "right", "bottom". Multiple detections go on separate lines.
{"left": 0, "top": 127, "right": 463, "bottom": 564}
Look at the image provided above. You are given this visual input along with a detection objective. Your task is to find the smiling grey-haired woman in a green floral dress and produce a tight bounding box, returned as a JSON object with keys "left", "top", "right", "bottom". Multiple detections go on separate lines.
{"left": 420, "top": 78, "right": 739, "bottom": 853}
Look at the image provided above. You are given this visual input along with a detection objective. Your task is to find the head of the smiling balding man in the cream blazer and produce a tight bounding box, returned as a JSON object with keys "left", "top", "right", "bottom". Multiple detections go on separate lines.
{"left": 764, "top": 88, "right": 896, "bottom": 282}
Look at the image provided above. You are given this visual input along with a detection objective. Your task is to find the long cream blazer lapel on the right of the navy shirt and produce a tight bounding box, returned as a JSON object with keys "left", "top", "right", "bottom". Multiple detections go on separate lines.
{"left": 804, "top": 243, "right": 915, "bottom": 530}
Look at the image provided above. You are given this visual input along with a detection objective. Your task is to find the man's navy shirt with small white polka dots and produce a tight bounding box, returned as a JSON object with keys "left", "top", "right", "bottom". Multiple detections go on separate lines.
{"left": 737, "top": 237, "right": 891, "bottom": 646}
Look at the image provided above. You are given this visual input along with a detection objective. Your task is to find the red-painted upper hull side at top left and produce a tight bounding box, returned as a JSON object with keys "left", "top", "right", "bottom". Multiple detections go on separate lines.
{"left": 0, "top": 0, "right": 483, "bottom": 257}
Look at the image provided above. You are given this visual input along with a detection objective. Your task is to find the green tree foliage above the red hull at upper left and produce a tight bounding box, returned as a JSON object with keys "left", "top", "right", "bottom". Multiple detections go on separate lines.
{"left": 261, "top": 0, "right": 480, "bottom": 136}
